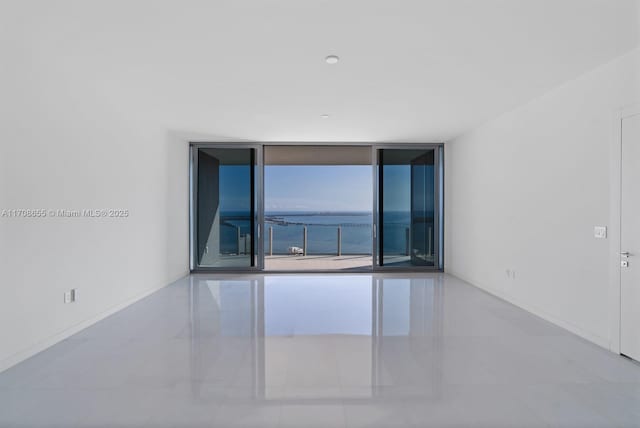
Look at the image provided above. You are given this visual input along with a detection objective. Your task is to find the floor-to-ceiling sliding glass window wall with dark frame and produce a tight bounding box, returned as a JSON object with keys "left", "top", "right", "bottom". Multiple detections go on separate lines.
{"left": 191, "top": 143, "right": 443, "bottom": 271}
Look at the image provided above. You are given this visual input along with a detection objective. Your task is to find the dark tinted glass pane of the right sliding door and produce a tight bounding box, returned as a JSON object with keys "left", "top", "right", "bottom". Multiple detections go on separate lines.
{"left": 379, "top": 149, "right": 436, "bottom": 266}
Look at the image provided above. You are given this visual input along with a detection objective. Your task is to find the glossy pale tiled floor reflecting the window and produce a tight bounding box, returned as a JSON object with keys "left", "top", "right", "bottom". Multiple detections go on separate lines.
{"left": 0, "top": 274, "right": 640, "bottom": 428}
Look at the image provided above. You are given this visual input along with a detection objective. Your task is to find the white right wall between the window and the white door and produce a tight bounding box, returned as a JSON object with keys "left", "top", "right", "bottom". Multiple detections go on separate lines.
{"left": 445, "top": 50, "right": 640, "bottom": 347}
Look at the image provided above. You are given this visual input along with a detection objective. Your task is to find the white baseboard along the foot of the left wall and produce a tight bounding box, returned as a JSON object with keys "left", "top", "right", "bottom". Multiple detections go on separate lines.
{"left": 0, "top": 272, "right": 189, "bottom": 373}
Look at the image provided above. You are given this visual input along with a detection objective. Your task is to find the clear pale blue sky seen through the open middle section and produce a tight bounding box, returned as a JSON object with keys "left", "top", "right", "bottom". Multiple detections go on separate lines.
{"left": 264, "top": 165, "right": 373, "bottom": 211}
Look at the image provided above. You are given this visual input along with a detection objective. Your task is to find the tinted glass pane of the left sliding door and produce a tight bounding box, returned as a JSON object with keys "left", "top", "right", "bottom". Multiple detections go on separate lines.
{"left": 196, "top": 148, "right": 255, "bottom": 268}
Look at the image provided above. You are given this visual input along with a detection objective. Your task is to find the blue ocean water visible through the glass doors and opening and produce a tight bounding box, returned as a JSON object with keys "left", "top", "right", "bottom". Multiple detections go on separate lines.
{"left": 221, "top": 211, "right": 424, "bottom": 255}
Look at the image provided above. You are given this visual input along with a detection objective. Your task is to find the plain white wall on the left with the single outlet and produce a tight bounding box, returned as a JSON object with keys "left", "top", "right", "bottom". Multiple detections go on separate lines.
{"left": 0, "top": 23, "right": 188, "bottom": 371}
